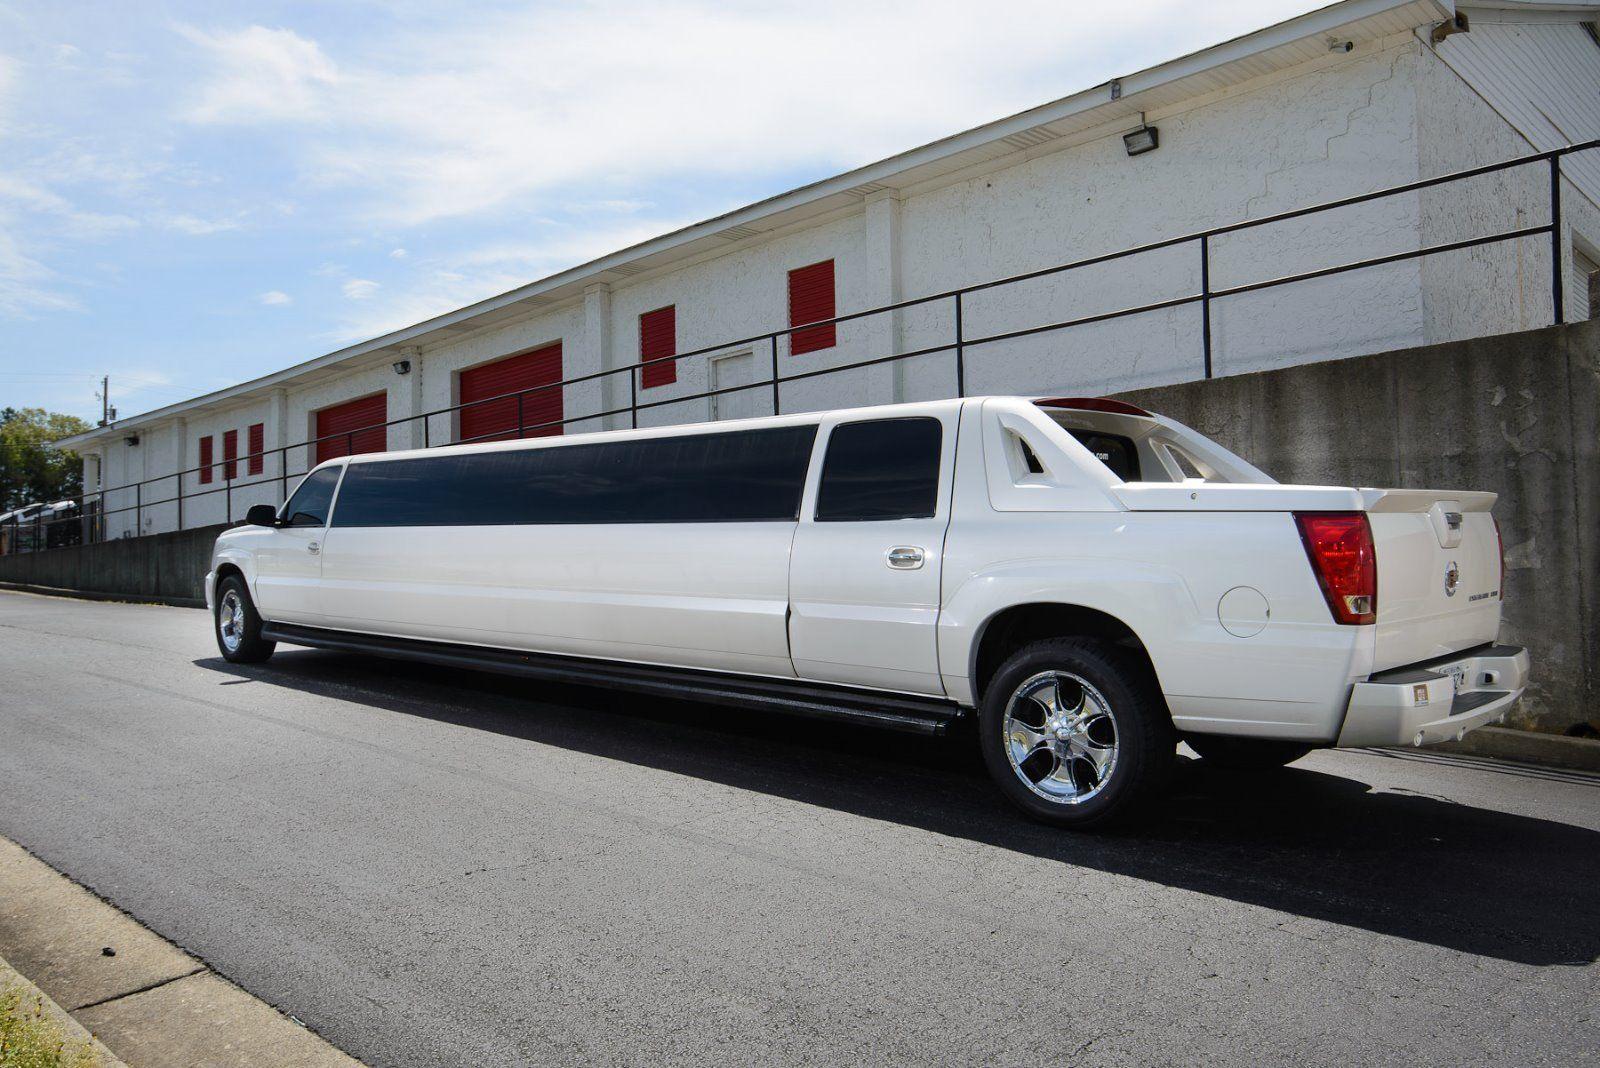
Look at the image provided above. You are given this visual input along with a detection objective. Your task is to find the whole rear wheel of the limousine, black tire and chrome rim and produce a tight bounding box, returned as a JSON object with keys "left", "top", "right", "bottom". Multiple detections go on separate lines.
{"left": 978, "top": 638, "right": 1178, "bottom": 830}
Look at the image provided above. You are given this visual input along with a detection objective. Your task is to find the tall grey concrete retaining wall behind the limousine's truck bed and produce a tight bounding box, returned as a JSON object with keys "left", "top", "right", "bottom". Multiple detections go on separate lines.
{"left": 1123, "top": 313, "right": 1600, "bottom": 732}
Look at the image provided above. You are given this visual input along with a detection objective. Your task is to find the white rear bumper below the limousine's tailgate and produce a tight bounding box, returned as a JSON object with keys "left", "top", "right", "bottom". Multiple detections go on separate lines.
{"left": 1334, "top": 646, "right": 1528, "bottom": 747}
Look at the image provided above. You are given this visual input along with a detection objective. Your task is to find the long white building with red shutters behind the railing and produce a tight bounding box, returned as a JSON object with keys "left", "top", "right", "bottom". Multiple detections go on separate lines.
{"left": 66, "top": 0, "right": 1600, "bottom": 537}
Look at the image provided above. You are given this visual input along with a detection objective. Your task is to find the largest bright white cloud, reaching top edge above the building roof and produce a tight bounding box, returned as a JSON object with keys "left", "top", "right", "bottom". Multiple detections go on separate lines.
{"left": 184, "top": 0, "right": 1310, "bottom": 225}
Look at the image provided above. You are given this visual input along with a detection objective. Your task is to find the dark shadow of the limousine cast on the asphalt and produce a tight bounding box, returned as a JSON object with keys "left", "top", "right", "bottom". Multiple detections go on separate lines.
{"left": 195, "top": 649, "right": 1600, "bottom": 966}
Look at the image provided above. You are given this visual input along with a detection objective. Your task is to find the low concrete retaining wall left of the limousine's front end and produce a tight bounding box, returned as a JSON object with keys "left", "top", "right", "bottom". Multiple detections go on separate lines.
{"left": 0, "top": 523, "right": 227, "bottom": 603}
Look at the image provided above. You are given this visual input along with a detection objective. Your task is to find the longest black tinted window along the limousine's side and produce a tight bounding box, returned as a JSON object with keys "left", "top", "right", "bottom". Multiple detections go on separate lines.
{"left": 334, "top": 427, "right": 816, "bottom": 526}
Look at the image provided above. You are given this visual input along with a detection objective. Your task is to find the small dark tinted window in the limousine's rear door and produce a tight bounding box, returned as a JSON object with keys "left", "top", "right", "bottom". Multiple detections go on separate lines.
{"left": 816, "top": 419, "right": 944, "bottom": 521}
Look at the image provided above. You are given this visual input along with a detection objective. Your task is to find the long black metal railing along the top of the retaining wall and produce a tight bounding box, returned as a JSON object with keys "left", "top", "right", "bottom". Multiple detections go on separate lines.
{"left": 9, "top": 139, "right": 1600, "bottom": 552}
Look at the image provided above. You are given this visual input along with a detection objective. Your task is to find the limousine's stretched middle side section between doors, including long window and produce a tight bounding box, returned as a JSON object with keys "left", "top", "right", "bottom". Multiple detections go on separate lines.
{"left": 322, "top": 420, "right": 816, "bottom": 676}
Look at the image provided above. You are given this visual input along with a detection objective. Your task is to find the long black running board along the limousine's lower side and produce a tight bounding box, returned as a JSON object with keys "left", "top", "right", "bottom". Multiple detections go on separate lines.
{"left": 261, "top": 622, "right": 966, "bottom": 734}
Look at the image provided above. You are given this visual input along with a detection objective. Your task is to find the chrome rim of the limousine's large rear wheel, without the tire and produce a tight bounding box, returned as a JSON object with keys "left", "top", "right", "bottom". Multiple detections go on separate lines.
{"left": 1005, "top": 671, "right": 1117, "bottom": 804}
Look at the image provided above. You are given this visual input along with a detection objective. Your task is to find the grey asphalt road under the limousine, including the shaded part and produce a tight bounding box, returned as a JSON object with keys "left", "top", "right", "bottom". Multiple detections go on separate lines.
{"left": 0, "top": 593, "right": 1600, "bottom": 1066}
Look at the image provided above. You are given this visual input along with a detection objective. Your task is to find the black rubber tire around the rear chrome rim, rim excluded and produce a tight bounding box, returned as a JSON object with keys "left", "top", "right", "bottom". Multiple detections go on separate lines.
{"left": 978, "top": 638, "right": 1178, "bottom": 830}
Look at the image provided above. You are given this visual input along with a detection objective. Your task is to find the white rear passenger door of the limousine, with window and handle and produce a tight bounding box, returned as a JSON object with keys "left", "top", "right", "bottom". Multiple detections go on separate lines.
{"left": 789, "top": 408, "right": 955, "bottom": 694}
